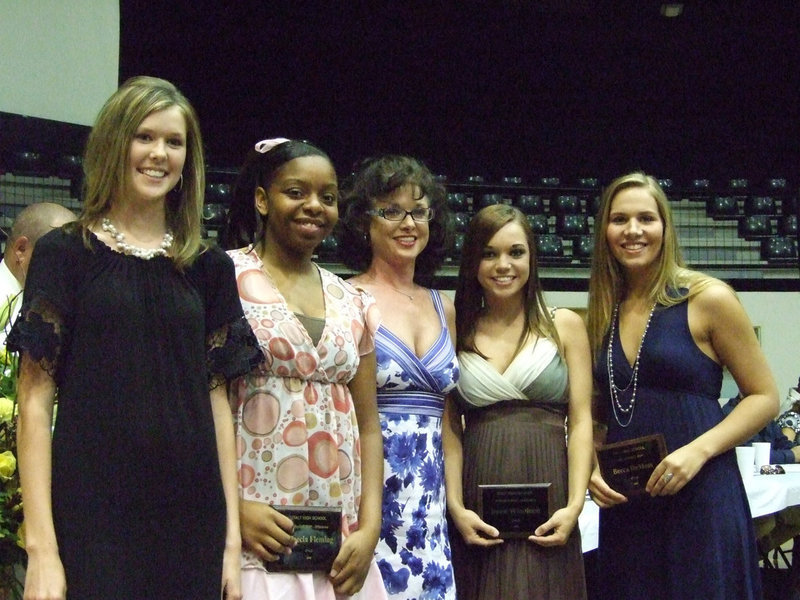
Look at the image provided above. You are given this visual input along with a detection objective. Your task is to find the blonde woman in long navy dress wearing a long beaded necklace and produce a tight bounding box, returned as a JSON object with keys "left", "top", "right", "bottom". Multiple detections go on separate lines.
{"left": 589, "top": 173, "right": 778, "bottom": 600}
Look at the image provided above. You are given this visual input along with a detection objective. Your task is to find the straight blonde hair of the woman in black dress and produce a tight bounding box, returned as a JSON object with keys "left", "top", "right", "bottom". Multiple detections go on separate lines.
{"left": 78, "top": 77, "right": 205, "bottom": 268}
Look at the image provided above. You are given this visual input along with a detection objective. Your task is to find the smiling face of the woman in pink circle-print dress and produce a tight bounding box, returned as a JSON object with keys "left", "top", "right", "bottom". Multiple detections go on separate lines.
{"left": 255, "top": 156, "right": 339, "bottom": 254}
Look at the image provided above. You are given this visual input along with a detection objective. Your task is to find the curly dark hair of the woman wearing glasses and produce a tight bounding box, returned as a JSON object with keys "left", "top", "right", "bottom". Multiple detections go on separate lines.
{"left": 337, "top": 154, "right": 453, "bottom": 287}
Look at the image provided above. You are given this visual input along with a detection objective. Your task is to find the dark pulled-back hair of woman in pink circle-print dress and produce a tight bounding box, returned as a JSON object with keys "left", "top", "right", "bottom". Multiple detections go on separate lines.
{"left": 219, "top": 140, "right": 333, "bottom": 250}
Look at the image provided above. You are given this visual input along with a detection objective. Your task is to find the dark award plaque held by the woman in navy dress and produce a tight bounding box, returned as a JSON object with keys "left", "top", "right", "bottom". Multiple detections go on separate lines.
{"left": 597, "top": 433, "right": 667, "bottom": 497}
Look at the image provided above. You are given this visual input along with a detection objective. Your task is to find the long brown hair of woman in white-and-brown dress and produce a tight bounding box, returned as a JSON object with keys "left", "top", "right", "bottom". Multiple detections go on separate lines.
{"left": 455, "top": 204, "right": 561, "bottom": 358}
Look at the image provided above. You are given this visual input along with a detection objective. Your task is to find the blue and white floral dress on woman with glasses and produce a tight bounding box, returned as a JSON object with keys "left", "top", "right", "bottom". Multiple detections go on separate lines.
{"left": 375, "top": 290, "right": 458, "bottom": 600}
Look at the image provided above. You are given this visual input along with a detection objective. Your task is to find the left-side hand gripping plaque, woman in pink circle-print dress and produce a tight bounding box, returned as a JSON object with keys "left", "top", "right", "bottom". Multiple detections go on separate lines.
{"left": 239, "top": 500, "right": 297, "bottom": 562}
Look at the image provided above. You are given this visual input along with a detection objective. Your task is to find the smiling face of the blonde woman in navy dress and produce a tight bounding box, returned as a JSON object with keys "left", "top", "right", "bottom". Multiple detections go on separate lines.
{"left": 606, "top": 187, "right": 664, "bottom": 271}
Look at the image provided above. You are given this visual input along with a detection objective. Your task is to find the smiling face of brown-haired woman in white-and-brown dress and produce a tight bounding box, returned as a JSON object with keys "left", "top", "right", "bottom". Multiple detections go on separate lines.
{"left": 478, "top": 221, "right": 531, "bottom": 300}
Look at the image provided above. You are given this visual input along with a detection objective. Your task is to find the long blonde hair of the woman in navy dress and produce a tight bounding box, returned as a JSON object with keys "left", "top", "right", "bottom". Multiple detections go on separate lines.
{"left": 587, "top": 172, "right": 722, "bottom": 356}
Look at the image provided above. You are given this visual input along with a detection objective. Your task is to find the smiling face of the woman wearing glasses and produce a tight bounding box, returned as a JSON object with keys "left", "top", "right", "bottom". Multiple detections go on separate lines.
{"left": 369, "top": 184, "right": 430, "bottom": 262}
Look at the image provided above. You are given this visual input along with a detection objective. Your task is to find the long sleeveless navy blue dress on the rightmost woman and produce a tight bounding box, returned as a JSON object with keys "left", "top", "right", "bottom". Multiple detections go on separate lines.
{"left": 595, "top": 302, "right": 761, "bottom": 600}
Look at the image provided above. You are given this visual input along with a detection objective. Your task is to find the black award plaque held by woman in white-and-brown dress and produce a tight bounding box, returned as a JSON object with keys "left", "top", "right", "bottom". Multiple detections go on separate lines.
{"left": 478, "top": 483, "right": 553, "bottom": 539}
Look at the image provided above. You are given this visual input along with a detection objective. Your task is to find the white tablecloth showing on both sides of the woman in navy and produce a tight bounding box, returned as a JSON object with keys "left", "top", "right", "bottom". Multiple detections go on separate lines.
{"left": 578, "top": 465, "right": 800, "bottom": 552}
